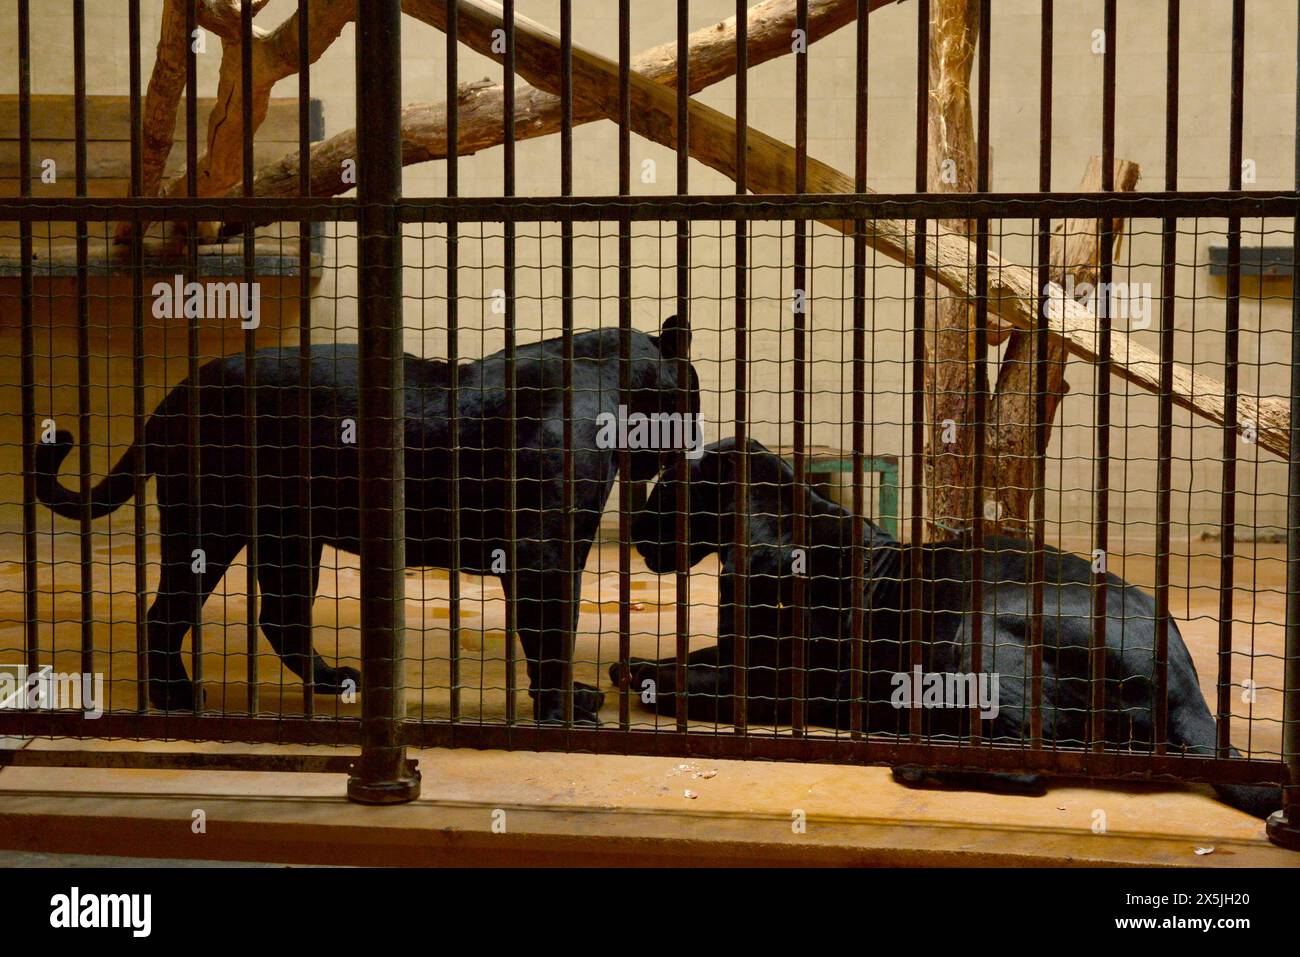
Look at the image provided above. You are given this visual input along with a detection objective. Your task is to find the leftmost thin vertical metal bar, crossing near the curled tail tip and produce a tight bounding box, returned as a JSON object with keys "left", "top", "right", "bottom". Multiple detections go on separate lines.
{"left": 18, "top": 0, "right": 40, "bottom": 671}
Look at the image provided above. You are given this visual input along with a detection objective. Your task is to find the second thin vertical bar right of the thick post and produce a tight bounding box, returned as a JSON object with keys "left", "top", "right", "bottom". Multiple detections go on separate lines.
{"left": 502, "top": 0, "right": 517, "bottom": 726}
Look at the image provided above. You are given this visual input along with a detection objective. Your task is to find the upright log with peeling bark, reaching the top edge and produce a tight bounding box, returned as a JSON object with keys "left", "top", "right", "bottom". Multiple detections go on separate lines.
{"left": 924, "top": 0, "right": 979, "bottom": 537}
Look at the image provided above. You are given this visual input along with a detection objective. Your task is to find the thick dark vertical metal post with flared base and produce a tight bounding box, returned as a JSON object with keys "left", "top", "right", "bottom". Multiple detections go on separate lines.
{"left": 347, "top": 0, "right": 420, "bottom": 804}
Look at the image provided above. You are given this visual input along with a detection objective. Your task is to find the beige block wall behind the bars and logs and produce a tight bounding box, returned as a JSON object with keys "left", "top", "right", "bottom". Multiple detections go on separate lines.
{"left": 0, "top": 0, "right": 1296, "bottom": 544}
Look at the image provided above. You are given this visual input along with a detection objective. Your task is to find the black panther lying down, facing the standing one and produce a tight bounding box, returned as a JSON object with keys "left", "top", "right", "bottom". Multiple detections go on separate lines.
{"left": 624, "top": 439, "right": 1282, "bottom": 817}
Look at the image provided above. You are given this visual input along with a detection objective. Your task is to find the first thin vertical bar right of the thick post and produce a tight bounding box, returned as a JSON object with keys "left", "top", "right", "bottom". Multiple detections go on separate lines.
{"left": 446, "top": 0, "right": 462, "bottom": 722}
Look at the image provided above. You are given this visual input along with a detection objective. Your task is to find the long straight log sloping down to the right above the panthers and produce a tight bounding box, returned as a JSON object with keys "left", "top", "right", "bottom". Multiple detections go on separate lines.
{"left": 421, "top": 0, "right": 1291, "bottom": 458}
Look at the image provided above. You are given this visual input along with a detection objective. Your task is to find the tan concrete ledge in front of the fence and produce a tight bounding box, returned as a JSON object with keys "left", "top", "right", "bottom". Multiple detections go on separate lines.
{"left": 0, "top": 741, "right": 1300, "bottom": 867}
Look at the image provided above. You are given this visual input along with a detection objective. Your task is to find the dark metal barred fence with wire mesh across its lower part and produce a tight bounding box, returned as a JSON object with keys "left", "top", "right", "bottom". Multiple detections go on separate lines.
{"left": 0, "top": 0, "right": 1300, "bottom": 840}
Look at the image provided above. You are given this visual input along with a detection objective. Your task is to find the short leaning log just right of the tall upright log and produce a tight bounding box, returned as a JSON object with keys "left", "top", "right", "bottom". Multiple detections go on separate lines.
{"left": 987, "top": 156, "right": 1141, "bottom": 536}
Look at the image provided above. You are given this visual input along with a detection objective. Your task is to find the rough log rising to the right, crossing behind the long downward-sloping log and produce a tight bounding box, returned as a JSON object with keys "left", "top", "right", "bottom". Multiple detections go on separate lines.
{"left": 244, "top": 0, "right": 897, "bottom": 196}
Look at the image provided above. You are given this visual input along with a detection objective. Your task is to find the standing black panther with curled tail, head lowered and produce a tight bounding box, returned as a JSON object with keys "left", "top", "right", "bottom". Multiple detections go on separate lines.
{"left": 36, "top": 317, "right": 699, "bottom": 722}
